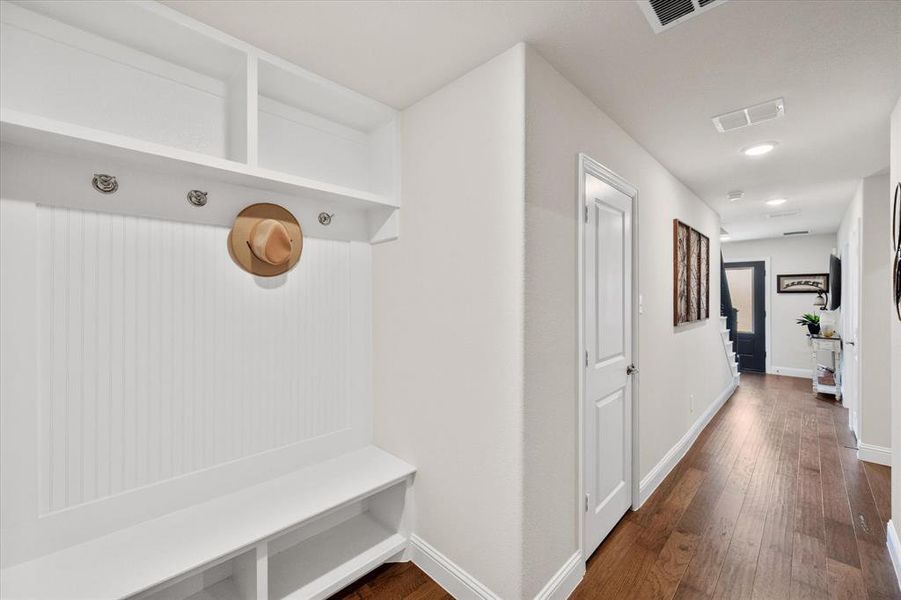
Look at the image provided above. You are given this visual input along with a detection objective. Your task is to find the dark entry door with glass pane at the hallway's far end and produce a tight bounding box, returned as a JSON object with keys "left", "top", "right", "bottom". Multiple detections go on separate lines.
{"left": 726, "top": 261, "right": 766, "bottom": 372}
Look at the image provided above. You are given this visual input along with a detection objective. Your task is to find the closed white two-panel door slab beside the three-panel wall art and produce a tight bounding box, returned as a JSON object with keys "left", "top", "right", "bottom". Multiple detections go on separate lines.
{"left": 582, "top": 165, "right": 632, "bottom": 557}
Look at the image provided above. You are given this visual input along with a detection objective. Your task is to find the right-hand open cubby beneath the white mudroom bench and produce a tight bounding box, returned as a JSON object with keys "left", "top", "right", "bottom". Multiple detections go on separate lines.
{"left": 269, "top": 513, "right": 407, "bottom": 600}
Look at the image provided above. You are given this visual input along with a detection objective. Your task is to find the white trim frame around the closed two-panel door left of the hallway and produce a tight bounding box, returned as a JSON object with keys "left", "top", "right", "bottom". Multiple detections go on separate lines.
{"left": 575, "top": 153, "right": 641, "bottom": 562}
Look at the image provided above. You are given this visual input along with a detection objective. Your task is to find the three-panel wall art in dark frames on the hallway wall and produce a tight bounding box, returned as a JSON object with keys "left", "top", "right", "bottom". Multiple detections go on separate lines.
{"left": 673, "top": 219, "right": 710, "bottom": 325}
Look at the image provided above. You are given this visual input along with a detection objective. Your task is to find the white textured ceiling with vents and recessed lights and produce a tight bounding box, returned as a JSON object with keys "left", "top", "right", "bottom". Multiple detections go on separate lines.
{"left": 165, "top": 0, "right": 901, "bottom": 239}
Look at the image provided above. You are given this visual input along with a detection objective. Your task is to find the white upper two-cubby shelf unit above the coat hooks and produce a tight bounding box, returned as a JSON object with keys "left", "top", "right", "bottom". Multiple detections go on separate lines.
{"left": 0, "top": 0, "right": 400, "bottom": 241}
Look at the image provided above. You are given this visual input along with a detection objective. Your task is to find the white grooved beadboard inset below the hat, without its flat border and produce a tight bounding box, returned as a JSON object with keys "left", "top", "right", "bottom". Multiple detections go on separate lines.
{"left": 38, "top": 207, "right": 350, "bottom": 512}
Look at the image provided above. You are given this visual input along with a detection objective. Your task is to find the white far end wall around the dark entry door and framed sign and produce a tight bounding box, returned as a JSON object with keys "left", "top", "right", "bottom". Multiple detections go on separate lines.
{"left": 723, "top": 234, "right": 837, "bottom": 377}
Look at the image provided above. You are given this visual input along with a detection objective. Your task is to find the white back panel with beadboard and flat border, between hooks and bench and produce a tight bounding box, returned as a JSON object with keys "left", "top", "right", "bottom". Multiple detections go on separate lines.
{"left": 0, "top": 199, "right": 372, "bottom": 566}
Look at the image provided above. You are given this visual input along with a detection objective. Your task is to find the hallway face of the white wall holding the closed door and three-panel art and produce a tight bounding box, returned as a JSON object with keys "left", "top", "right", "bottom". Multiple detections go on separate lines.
{"left": 524, "top": 49, "right": 731, "bottom": 597}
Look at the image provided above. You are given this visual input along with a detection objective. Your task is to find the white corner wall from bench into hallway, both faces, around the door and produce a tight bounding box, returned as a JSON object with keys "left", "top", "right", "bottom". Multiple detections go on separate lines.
{"left": 373, "top": 46, "right": 732, "bottom": 598}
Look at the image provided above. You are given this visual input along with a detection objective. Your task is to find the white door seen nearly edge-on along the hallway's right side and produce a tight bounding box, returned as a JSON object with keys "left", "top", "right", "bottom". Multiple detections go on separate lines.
{"left": 841, "top": 220, "right": 861, "bottom": 438}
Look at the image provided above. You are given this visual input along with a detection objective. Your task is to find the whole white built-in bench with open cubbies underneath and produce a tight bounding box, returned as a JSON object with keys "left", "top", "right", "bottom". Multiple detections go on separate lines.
{"left": 0, "top": 446, "right": 415, "bottom": 600}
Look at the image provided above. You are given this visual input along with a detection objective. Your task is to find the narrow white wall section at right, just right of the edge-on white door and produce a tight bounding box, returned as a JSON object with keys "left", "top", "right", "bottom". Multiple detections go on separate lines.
{"left": 838, "top": 174, "right": 892, "bottom": 449}
